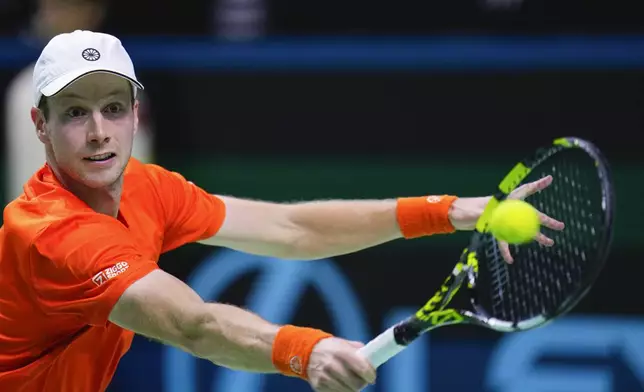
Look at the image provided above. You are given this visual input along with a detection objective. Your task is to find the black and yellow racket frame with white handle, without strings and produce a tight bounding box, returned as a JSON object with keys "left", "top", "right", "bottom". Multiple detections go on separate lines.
{"left": 360, "top": 137, "right": 615, "bottom": 368}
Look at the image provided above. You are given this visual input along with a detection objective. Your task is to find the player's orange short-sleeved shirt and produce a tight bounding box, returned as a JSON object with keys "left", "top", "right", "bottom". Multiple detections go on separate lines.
{"left": 0, "top": 159, "right": 225, "bottom": 392}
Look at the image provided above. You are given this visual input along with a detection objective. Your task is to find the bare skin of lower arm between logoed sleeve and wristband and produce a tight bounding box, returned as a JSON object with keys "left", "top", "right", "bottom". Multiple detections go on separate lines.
{"left": 109, "top": 270, "right": 278, "bottom": 373}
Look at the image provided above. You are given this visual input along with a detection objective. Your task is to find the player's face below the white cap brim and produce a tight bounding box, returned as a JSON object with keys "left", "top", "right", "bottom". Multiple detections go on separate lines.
{"left": 34, "top": 73, "right": 138, "bottom": 189}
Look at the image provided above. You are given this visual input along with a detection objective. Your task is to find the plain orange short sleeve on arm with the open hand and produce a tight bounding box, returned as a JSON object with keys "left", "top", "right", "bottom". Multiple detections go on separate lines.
{"left": 146, "top": 164, "right": 226, "bottom": 252}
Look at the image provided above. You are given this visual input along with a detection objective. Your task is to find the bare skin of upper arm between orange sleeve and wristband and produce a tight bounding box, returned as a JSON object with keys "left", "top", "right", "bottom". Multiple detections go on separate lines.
{"left": 202, "top": 196, "right": 401, "bottom": 259}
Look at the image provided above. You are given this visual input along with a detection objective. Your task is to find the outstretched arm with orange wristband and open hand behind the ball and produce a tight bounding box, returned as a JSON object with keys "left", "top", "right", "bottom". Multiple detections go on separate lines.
{"left": 201, "top": 177, "right": 563, "bottom": 261}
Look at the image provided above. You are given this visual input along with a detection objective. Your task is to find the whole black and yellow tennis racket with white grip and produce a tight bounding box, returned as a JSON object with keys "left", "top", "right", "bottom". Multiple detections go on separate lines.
{"left": 360, "top": 137, "right": 615, "bottom": 368}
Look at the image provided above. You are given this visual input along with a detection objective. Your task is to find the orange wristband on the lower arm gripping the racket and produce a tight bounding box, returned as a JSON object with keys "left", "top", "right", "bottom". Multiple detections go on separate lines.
{"left": 272, "top": 325, "right": 333, "bottom": 380}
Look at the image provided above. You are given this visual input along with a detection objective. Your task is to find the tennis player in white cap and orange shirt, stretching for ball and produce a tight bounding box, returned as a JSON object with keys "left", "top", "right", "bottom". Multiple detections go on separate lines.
{"left": 0, "top": 31, "right": 561, "bottom": 392}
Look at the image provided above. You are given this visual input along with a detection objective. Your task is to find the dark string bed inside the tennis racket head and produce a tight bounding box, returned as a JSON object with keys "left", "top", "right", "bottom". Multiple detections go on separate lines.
{"left": 477, "top": 150, "right": 607, "bottom": 322}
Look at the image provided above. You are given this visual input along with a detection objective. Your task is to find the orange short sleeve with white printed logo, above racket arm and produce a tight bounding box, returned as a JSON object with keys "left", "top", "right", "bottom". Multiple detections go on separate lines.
{"left": 29, "top": 213, "right": 158, "bottom": 326}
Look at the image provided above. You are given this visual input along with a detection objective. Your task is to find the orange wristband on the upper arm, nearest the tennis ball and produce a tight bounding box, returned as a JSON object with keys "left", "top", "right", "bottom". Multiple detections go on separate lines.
{"left": 396, "top": 195, "right": 457, "bottom": 239}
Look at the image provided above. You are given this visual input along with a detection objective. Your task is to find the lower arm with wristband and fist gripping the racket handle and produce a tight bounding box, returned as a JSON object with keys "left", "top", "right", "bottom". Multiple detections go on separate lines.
{"left": 109, "top": 269, "right": 376, "bottom": 392}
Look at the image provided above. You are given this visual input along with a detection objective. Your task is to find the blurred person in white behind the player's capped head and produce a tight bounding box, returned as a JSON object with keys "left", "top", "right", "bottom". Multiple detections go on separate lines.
{"left": 5, "top": 0, "right": 153, "bottom": 201}
